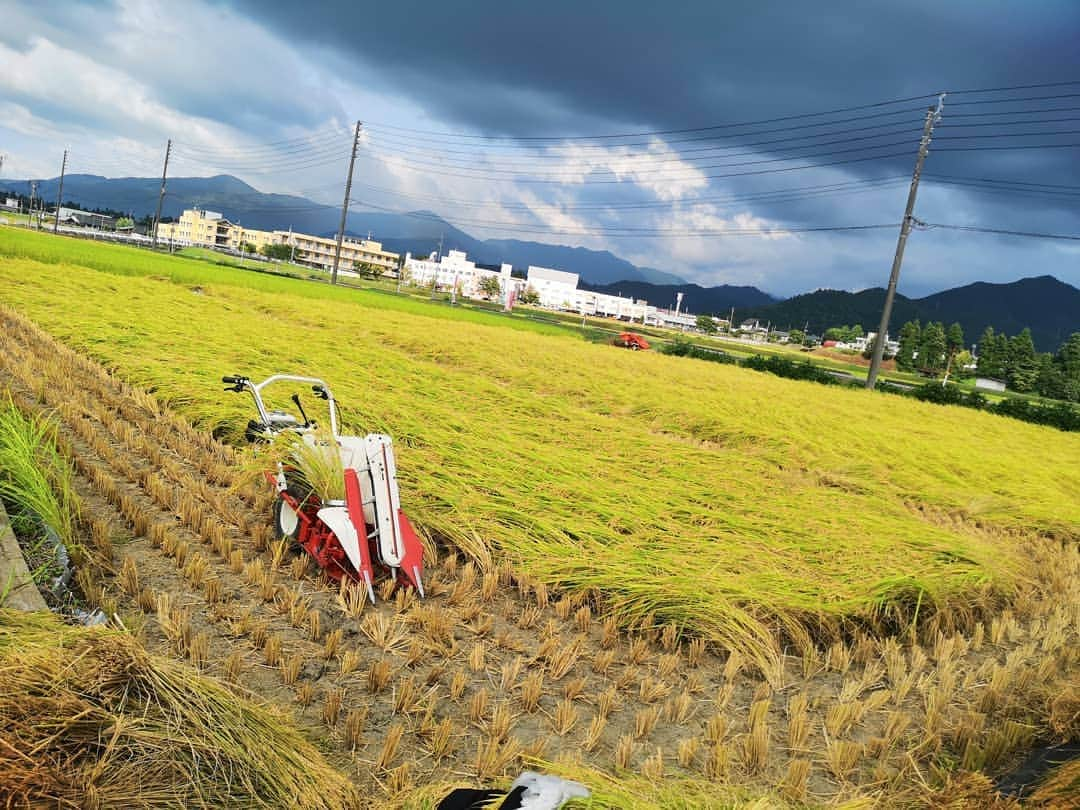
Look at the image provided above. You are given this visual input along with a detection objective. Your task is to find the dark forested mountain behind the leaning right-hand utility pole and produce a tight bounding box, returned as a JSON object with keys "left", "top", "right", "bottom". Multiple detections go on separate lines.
{"left": 735, "top": 275, "right": 1080, "bottom": 351}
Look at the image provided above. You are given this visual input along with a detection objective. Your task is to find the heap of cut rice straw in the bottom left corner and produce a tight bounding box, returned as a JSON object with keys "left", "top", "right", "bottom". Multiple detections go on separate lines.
{"left": 0, "top": 610, "right": 361, "bottom": 808}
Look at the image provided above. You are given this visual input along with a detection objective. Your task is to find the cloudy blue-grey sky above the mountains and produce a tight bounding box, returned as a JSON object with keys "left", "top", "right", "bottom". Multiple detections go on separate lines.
{"left": 0, "top": 0, "right": 1080, "bottom": 295}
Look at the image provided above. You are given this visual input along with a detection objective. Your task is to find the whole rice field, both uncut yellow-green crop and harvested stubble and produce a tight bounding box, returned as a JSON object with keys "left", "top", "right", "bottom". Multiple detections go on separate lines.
{"left": 0, "top": 229, "right": 1080, "bottom": 810}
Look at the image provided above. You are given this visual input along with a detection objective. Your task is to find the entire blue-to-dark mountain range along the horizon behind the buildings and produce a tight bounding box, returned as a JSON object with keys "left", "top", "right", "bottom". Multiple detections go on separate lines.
{"left": 0, "top": 175, "right": 1080, "bottom": 351}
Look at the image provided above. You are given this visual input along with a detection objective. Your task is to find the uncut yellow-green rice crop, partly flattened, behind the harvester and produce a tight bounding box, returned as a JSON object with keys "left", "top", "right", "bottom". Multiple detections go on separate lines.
{"left": 0, "top": 226, "right": 1080, "bottom": 670}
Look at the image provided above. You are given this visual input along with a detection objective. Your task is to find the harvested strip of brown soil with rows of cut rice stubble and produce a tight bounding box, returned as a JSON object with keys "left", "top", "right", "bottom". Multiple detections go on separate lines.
{"left": 0, "top": 310, "right": 1080, "bottom": 800}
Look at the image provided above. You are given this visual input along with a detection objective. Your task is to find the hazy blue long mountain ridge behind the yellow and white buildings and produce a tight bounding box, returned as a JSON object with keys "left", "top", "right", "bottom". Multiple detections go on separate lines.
{"left": 0, "top": 174, "right": 684, "bottom": 284}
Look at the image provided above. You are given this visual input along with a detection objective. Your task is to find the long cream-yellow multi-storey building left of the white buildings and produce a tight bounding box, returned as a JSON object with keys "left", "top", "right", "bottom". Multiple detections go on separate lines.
{"left": 158, "top": 208, "right": 399, "bottom": 272}
